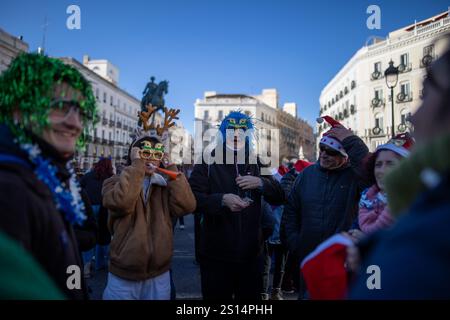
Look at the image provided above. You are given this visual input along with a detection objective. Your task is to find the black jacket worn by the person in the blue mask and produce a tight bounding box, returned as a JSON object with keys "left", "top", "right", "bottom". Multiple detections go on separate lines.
{"left": 189, "top": 150, "right": 285, "bottom": 262}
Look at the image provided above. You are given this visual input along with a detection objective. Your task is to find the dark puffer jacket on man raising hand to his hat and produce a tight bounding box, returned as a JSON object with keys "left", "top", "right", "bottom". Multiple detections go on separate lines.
{"left": 282, "top": 136, "right": 368, "bottom": 259}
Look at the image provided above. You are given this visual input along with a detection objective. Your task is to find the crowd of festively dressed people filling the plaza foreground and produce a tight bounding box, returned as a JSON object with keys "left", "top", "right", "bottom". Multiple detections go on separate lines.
{"left": 0, "top": 34, "right": 450, "bottom": 301}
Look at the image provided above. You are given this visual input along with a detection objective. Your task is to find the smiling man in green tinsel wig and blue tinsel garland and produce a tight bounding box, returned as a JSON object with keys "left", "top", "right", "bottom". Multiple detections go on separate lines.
{"left": 0, "top": 53, "right": 96, "bottom": 299}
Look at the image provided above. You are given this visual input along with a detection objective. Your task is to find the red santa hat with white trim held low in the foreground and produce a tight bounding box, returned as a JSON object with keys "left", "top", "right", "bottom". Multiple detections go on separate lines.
{"left": 301, "top": 234, "right": 353, "bottom": 300}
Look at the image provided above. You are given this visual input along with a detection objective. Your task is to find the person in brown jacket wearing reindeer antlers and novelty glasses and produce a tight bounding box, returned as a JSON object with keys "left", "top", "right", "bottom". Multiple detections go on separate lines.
{"left": 102, "top": 105, "right": 196, "bottom": 300}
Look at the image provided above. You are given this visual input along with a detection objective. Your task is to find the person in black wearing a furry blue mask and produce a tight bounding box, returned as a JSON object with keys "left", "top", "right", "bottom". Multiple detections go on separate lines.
{"left": 189, "top": 111, "right": 284, "bottom": 300}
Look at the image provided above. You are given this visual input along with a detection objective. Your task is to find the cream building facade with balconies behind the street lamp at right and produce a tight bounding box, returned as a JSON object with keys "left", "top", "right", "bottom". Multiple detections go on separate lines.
{"left": 316, "top": 12, "right": 450, "bottom": 151}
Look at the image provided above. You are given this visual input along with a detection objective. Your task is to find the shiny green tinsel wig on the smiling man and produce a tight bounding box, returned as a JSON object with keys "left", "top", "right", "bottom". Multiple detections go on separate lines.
{"left": 0, "top": 53, "right": 98, "bottom": 150}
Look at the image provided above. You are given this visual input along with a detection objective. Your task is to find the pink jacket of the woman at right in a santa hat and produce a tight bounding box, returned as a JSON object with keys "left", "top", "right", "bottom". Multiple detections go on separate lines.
{"left": 358, "top": 185, "right": 394, "bottom": 233}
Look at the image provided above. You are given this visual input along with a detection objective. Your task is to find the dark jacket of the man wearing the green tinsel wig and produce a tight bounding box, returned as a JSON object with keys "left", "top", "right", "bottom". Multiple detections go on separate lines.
{"left": 0, "top": 125, "right": 87, "bottom": 299}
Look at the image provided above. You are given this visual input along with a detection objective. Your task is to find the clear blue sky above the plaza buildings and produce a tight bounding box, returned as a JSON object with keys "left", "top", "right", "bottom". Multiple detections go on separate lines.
{"left": 0, "top": 0, "right": 450, "bottom": 132}
